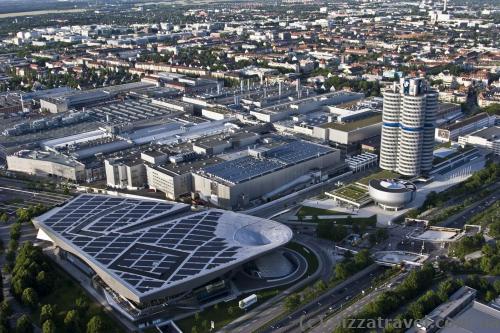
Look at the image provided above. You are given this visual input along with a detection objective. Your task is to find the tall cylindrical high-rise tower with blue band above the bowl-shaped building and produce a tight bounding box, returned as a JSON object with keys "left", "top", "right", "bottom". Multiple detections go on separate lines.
{"left": 380, "top": 78, "right": 438, "bottom": 176}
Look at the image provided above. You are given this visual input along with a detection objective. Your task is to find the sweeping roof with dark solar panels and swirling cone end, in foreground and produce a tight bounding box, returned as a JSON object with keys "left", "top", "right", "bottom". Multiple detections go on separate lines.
{"left": 34, "top": 194, "right": 291, "bottom": 302}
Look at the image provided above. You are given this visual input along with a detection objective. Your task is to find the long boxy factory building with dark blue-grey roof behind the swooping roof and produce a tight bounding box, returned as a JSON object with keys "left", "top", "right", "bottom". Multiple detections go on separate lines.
{"left": 193, "top": 141, "right": 340, "bottom": 209}
